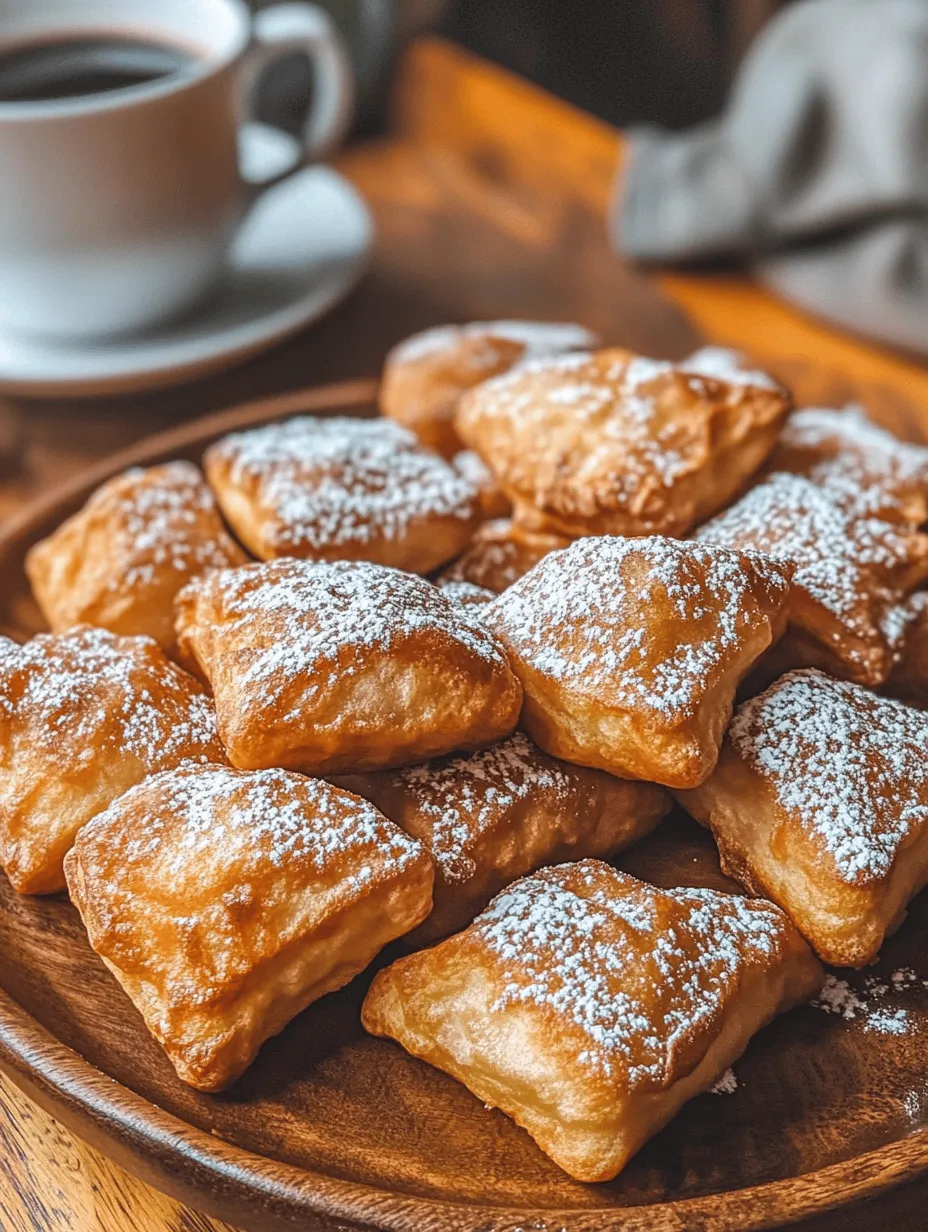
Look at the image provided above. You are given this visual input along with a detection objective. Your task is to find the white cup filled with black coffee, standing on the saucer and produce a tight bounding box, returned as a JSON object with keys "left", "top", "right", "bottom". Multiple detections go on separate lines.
{"left": 0, "top": 0, "right": 354, "bottom": 339}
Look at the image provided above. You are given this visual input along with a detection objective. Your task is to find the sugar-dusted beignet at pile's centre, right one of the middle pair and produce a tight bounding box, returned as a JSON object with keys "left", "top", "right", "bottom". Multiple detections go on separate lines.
{"left": 481, "top": 537, "right": 792, "bottom": 787}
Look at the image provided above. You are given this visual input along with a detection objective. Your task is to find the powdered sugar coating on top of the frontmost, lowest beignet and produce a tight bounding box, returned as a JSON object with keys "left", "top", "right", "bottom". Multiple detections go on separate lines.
{"left": 472, "top": 860, "right": 789, "bottom": 1089}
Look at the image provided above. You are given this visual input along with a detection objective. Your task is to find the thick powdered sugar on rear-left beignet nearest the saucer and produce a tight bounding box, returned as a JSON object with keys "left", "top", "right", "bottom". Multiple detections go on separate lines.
{"left": 207, "top": 415, "right": 479, "bottom": 552}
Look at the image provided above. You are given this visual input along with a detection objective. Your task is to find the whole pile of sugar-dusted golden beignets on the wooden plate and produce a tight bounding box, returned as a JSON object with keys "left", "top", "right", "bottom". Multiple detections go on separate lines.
{"left": 14, "top": 323, "right": 928, "bottom": 1180}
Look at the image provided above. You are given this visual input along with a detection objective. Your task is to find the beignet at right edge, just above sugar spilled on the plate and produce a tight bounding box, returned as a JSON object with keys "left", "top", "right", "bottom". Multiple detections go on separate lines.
{"left": 678, "top": 670, "right": 928, "bottom": 967}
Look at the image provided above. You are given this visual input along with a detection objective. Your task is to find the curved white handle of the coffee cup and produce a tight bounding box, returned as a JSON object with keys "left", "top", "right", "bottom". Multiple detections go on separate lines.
{"left": 242, "top": 2, "right": 355, "bottom": 195}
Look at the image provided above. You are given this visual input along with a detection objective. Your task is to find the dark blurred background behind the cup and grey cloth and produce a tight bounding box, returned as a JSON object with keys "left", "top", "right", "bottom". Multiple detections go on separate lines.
{"left": 254, "top": 0, "right": 790, "bottom": 131}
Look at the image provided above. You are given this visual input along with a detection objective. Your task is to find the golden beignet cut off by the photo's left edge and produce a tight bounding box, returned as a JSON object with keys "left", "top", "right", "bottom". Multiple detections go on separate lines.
{"left": 0, "top": 626, "right": 226, "bottom": 894}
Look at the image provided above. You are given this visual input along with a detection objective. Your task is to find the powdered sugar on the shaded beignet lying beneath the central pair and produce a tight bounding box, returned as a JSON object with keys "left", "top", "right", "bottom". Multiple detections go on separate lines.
{"left": 396, "top": 732, "right": 574, "bottom": 882}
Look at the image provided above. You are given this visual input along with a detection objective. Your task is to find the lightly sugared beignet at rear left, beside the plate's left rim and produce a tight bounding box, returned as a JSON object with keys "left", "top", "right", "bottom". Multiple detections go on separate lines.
{"left": 26, "top": 462, "right": 248, "bottom": 654}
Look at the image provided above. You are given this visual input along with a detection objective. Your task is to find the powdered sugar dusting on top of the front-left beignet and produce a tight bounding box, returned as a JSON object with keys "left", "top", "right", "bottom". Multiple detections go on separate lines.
{"left": 99, "top": 766, "right": 421, "bottom": 890}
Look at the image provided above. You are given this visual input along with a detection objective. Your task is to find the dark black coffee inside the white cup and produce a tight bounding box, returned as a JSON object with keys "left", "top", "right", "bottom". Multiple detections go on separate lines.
{"left": 0, "top": 38, "right": 196, "bottom": 102}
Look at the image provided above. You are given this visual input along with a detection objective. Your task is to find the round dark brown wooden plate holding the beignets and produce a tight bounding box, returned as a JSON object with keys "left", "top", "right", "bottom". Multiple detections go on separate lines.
{"left": 0, "top": 382, "right": 928, "bottom": 1232}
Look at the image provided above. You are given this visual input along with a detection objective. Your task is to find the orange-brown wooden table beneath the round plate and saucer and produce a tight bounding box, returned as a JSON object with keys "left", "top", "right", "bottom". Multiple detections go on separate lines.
{"left": 0, "top": 39, "right": 928, "bottom": 1232}
